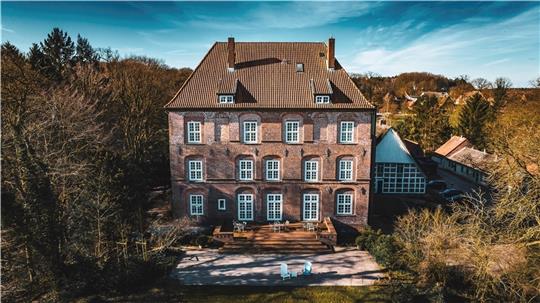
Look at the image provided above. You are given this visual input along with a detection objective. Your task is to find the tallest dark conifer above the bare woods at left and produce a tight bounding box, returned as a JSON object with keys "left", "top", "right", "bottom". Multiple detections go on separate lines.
{"left": 40, "top": 27, "right": 75, "bottom": 81}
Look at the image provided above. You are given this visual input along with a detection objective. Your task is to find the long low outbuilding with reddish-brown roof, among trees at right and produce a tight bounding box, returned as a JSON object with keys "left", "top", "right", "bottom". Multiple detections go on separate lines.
{"left": 432, "top": 136, "right": 495, "bottom": 185}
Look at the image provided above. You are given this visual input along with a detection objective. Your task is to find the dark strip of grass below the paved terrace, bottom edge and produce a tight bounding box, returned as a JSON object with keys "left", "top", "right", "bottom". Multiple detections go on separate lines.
{"left": 100, "top": 281, "right": 390, "bottom": 303}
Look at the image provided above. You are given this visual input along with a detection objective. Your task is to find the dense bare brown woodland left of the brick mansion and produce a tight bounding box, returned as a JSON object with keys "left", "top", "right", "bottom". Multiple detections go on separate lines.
{"left": 1, "top": 28, "right": 191, "bottom": 302}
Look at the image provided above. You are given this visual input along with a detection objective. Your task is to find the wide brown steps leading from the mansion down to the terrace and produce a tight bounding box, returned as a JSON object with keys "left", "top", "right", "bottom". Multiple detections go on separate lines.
{"left": 221, "top": 224, "right": 332, "bottom": 254}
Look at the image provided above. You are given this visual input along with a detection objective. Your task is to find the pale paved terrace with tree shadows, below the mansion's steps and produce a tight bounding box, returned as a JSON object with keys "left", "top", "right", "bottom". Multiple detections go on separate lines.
{"left": 171, "top": 249, "right": 384, "bottom": 286}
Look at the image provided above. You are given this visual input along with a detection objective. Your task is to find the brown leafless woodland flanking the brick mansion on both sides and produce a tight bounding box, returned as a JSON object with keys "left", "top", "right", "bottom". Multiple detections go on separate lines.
{"left": 1, "top": 28, "right": 540, "bottom": 302}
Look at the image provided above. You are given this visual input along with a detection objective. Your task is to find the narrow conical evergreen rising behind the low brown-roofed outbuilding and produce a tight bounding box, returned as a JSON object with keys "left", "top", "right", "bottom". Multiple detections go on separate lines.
{"left": 458, "top": 94, "right": 491, "bottom": 148}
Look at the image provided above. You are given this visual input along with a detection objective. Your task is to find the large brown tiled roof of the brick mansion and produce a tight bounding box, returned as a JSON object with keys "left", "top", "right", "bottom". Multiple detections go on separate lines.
{"left": 165, "top": 42, "right": 374, "bottom": 110}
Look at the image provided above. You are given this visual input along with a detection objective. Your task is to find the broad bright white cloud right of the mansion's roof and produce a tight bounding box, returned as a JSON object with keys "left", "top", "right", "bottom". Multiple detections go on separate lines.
{"left": 345, "top": 8, "right": 540, "bottom": 85}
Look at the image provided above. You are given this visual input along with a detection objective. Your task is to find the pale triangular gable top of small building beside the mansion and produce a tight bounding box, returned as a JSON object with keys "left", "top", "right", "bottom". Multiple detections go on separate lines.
{"left": 375, "top": 128, "right": 417, "bottom": 165}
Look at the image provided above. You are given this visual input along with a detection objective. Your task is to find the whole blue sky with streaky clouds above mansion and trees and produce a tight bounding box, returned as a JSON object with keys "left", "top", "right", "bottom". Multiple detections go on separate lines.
{"left": 1, "top": 1, "right": 540, "bottom": 86}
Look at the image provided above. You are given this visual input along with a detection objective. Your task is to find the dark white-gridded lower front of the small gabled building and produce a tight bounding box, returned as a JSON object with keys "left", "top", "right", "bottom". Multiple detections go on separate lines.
{"left": 375, "top": 163, "right": 426, "bottom": 193}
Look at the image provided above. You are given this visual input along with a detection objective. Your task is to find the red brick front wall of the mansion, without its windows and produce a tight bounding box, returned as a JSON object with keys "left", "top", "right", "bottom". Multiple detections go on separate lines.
{"left": 169, "top": 111, "right": 373, "bottom": 224}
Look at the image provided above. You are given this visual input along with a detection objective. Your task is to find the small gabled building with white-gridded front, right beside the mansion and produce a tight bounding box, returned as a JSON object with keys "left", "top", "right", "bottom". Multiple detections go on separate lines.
{"left": 374, "top": 128, "right": 426, "bottom": 194}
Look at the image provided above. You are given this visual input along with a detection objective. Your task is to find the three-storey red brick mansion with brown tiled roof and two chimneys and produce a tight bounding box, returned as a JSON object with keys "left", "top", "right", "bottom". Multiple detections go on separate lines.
{"left": 165, "top": 38, "right": 375, "bottom": 225}
